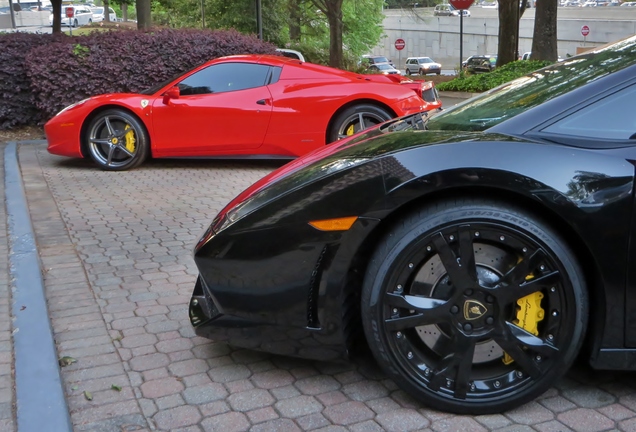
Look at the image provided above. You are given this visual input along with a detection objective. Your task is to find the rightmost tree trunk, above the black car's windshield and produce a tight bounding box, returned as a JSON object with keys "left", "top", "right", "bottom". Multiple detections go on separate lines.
{"left": 530, "top": 0, "right": 558, "bottom": 62}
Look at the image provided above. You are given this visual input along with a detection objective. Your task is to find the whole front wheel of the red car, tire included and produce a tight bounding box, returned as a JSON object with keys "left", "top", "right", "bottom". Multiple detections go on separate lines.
{"left": 86, "top": 109, "right": 149, "bottom": 171}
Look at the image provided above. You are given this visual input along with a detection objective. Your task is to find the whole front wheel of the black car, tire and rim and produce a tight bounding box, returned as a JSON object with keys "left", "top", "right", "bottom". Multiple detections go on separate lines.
{"left": 361, "top": 199, "right": 588, "bottom": 414}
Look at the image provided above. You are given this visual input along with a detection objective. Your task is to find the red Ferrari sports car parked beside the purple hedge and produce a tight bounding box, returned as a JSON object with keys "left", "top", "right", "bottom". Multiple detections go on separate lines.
{"left": 44, "top": 55, "right": 441, "bottom": 170}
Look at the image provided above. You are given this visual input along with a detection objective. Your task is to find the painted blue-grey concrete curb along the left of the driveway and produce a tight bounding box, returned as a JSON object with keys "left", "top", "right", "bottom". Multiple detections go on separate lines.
{"left": 4, "top": 141, "right": 73, "bottom": 432}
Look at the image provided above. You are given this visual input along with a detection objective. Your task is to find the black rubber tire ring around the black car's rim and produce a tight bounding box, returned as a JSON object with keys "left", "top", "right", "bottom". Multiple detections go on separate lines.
{"left": 361, "top": 204, "right": 588, "bottom": 414}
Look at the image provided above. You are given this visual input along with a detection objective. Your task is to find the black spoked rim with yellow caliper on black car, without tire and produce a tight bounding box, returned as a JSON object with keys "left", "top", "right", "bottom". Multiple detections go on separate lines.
{"left": 381, "top": 222, "right": 575, "bottom": 403}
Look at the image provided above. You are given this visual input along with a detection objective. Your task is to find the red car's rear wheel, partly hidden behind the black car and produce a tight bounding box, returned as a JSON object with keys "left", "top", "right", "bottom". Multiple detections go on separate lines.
{"left": 327, "top": 104, "right": 394, "bottom": 143}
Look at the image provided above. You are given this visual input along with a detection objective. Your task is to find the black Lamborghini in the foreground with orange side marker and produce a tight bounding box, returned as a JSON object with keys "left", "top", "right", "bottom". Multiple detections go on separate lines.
{"left": 189, "top": 36, "right": 636, "bottom": 416}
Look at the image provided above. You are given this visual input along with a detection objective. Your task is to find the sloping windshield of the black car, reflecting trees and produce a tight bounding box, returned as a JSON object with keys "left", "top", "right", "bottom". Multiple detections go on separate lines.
{"left": 427, "top": 36, "right": 636, "bottom": 131}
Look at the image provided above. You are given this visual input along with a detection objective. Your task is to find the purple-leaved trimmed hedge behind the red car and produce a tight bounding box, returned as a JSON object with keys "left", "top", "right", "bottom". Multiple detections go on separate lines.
{"left": 0, "top": 29, "right": 275, "bottom": 129}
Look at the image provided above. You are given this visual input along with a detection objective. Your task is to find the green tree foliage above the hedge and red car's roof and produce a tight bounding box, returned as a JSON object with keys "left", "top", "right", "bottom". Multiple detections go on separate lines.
{"left": 152, "top": 0, "right": 384, "bottom": 67}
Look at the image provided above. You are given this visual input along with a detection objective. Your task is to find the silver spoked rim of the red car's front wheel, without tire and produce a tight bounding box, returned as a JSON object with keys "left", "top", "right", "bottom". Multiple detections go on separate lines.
{"left": 88, "top": 114, "right": 138, "bottom": 168}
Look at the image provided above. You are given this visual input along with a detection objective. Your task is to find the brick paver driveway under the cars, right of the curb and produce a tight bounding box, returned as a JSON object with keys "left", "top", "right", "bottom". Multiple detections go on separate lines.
{"left": 14, "top": 145, "right": 636, "bottom": 432}
